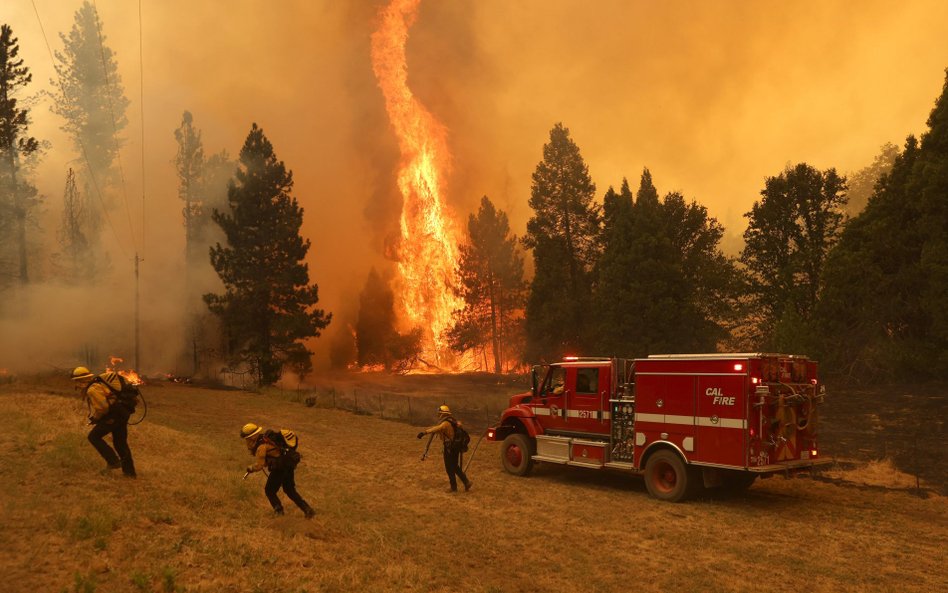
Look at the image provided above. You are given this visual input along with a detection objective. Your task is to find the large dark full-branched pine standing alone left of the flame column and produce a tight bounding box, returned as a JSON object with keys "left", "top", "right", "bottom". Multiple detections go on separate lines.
{"left": 204, "top": 124, "right": 332, "bottom": 386}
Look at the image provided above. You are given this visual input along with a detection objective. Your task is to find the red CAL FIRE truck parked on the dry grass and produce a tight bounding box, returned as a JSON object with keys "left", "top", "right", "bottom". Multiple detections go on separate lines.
{"left": 487, "top": 353, "right": 828, "bottom": 502}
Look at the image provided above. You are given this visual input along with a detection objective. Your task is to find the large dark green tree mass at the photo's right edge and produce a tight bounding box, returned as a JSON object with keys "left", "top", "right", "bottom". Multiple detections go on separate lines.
{"left": 817, "top": 70, "right": 948, "bottom": 380}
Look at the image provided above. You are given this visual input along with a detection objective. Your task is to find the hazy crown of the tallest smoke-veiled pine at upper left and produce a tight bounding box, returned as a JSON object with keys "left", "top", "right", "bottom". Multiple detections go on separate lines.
{"left": 51, "top": 0, "right": 129, "bottom": 197}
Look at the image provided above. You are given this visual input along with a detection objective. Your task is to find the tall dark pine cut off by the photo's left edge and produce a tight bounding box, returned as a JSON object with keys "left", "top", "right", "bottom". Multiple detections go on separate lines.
{"left": 0, "top": 25, "right": 39, "bottom": 285}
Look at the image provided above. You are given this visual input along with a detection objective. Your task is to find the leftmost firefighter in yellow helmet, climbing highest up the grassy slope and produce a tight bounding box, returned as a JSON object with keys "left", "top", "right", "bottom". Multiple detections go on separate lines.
{"left": 72, "top": 367, "right": 136, "bottom": 478}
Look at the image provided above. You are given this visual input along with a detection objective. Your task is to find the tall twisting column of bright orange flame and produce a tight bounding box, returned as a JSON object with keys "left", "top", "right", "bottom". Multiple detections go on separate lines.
{"left": 372, "top": 0, "right": 463, "bottom": 364}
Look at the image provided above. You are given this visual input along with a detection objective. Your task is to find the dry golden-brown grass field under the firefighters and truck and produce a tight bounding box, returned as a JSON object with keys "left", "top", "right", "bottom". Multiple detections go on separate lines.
{"left": 0, "top": 378, "right": 948, "bottom": 593}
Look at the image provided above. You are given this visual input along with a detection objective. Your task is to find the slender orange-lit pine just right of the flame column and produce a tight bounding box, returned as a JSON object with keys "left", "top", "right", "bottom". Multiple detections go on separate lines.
{"left": 450, "top": 196, "right": 525, "bottom": 373}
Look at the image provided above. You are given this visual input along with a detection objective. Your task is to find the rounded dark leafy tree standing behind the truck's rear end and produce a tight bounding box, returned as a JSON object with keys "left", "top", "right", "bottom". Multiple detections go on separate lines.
{"left": 741, "top": 163, "right": 846, "bottom": 350}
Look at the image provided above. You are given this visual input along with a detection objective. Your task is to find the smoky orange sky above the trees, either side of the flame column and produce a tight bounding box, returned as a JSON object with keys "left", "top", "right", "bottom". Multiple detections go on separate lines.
{"left": 0, "top": 0, "right": 948, "bottom": 370}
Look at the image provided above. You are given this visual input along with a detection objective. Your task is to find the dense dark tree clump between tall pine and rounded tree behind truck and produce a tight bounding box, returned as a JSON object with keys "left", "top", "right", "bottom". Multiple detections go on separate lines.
{"left": 594, "top": 169, "right": 737, "bottom": 356}
